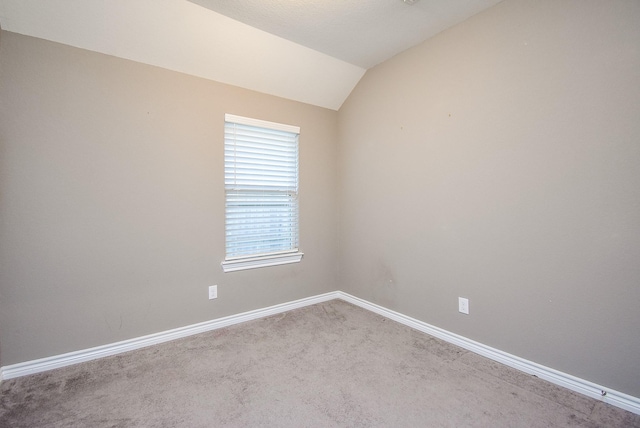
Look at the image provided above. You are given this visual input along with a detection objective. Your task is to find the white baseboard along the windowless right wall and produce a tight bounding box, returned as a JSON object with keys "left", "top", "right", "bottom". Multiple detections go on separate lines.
{"left": 337, "top": 291, "right": 640, "bottom": 415}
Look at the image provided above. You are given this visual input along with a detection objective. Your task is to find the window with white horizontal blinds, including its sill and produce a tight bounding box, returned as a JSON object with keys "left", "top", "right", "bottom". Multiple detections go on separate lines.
{"left": 222, "top": 114, "right": 302, "bottom": 272}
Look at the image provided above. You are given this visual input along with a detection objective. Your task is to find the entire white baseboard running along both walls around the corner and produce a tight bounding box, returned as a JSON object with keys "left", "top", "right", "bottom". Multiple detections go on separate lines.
{"left": 0, "top": 291, "right": 640, "bottom": 415}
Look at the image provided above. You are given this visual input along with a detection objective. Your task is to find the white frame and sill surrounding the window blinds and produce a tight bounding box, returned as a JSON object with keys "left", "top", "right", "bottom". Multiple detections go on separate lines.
{"left": 221, "top": 114, "right": 304, "bottom": 273}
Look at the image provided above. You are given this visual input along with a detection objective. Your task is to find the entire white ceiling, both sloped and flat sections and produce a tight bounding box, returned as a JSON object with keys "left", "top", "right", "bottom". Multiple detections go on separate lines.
{"left": 0, "top": 0, "right": 502, "bottom": 110}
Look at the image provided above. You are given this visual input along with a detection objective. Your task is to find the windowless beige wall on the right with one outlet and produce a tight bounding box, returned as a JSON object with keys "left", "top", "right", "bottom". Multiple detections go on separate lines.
{"left": 339, "top": 0, "right": 640, "bottom": 397}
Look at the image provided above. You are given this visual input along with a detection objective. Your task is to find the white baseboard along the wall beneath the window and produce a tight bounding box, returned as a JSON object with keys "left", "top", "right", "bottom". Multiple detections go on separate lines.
{"left": 0, "top": 292, "right": 338, "bottom": 381}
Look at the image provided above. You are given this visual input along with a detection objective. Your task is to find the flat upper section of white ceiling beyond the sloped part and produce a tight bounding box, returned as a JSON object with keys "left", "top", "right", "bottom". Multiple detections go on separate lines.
{"left": 190, "top": 0, "right": 501, "bottom": 69}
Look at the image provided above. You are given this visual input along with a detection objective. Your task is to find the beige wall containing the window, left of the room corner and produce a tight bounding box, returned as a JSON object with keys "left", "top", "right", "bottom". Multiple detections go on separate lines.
{"left": 0, "top": 32, "right": 338, "bottom": 365}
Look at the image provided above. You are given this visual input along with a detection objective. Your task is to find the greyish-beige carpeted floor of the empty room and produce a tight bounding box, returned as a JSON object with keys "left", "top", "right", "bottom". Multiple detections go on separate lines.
{"left": 0, "top": 300, "right": 640, "bottom": 428}
